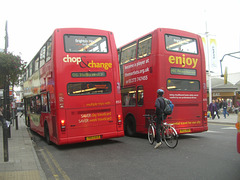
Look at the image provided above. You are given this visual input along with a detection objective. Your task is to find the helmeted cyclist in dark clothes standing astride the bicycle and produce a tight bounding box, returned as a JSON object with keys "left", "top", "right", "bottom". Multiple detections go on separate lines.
{"left": 154, "top": 89, "right": 165, "bottom": 149}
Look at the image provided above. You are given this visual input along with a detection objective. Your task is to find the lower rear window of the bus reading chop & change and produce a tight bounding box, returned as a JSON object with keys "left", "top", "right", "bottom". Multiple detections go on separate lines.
{"left": 67, "top": 82, "right": 112, "bottom": 96}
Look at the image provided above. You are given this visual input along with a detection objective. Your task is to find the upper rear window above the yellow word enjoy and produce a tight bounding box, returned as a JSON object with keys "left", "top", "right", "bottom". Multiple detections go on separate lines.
{"left": 165, "top": 34, "right": 198, "bottom": 54}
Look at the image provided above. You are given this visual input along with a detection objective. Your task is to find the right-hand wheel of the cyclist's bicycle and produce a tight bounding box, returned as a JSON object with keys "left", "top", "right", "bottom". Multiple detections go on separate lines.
{"left": 163, "top": 126, "right": 178, "bottom": 148}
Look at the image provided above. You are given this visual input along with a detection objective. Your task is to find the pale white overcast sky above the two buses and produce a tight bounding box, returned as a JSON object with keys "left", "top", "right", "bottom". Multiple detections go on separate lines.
{"left": 0, "top": 0, "right": 240, "bottom": 72}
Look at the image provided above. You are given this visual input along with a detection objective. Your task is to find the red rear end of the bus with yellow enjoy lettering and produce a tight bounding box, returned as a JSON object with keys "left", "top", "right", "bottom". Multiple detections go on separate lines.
{"left": 157, "top": 29, "right": 208, "bottom": 134}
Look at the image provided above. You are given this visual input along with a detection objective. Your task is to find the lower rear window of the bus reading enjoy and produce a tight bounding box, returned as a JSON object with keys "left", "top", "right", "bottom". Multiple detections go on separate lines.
{"left": 167, "top": 79, "right": 200, "bottom": 91}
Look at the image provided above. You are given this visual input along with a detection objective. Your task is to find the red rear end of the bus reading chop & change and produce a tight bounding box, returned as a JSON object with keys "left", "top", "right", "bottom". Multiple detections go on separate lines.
{"left": 49, "top": 28, "right": 124, "bottom": 144}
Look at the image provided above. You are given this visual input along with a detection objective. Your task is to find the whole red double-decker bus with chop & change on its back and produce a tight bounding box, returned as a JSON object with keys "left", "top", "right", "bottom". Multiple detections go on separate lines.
{"left": 24, "top": 28, "right": 124, "bottom": 145}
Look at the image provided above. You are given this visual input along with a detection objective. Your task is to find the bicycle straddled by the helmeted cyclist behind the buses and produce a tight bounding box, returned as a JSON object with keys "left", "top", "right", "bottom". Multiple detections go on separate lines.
{"left": 143, "top": 114, "right": 178, "bottom": 148}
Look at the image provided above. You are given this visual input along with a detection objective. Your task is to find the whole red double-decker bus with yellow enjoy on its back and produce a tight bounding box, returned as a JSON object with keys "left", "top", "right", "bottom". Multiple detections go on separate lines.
{"left": 118, "top": 28, "right": 208, "bottom": 135}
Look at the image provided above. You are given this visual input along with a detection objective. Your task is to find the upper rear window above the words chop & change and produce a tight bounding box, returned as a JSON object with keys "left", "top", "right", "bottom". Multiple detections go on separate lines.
{"left": 64, "top": 35, "right": 108, "bottom": 53}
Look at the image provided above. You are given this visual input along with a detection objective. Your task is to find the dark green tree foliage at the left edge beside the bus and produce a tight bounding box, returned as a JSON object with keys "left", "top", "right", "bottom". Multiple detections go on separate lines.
{"left": 0, "top": 52, "right": 26, "bottom": 87}
